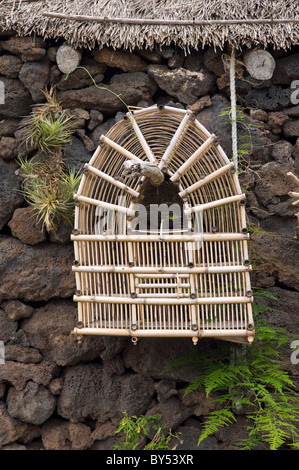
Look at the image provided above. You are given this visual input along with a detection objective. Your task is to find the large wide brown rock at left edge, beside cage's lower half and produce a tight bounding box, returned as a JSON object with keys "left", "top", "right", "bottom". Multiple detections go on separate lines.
{"left": 0, "top": 235, "right": 75, "bottom": 302}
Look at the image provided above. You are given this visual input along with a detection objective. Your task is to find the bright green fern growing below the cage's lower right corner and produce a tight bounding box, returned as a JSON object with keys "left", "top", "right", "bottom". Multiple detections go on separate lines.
{"left": 165, "top": 291, "right": 299, "bottom": 450}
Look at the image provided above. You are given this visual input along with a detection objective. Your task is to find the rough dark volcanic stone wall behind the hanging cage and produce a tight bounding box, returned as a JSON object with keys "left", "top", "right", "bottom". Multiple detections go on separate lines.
{"left": 0, "top": 35, "right": 299, "bottom": 450}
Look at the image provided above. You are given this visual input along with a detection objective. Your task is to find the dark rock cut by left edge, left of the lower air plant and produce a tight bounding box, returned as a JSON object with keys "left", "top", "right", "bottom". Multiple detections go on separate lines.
{"left": 0, "top": 159, "right": 23, "bottom": 230}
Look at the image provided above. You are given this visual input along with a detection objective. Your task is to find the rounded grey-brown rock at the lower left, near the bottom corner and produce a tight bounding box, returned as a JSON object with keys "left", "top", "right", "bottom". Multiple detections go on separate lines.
{"left": 6, "top": 382, "right": 56, "bottom": 426}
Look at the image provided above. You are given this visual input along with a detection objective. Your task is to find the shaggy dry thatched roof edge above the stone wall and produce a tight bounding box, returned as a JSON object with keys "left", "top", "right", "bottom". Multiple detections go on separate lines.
{"left": 0, "top": 0, "right": 299, "bottom": 49}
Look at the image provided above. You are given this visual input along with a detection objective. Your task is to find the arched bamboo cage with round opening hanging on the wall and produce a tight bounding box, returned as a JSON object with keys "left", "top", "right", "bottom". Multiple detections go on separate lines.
{"left": 72, "top": 105, "right": 254, "bottom": 344}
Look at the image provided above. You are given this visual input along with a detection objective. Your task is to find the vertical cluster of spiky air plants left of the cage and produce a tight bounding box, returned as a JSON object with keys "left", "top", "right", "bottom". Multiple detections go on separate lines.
{"left": 19, "top": 88, "right": 80, "bottom": 232}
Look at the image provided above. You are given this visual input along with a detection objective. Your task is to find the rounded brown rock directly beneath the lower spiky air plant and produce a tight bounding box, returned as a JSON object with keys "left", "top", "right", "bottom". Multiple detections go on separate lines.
{"left": 8, "top": 207, "right": 47, "bottom": 245}
